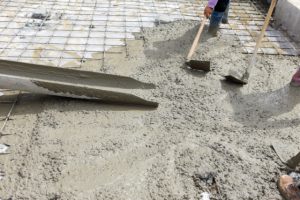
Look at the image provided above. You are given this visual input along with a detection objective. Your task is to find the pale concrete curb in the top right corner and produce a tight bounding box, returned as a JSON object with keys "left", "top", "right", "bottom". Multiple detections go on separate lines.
{"left": 275, "top": 0, "right": 300, "bottom": 42}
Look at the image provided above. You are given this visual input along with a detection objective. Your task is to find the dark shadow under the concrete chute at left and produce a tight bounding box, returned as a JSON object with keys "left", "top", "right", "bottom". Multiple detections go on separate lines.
{"left": 0, "top": 93, "right": 156, "bottom": 118}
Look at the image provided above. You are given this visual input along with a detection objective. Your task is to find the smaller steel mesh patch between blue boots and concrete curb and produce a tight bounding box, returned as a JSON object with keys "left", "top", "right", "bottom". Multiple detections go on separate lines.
{"left": 221, "top": 1, "right": 300, "bottom": 56}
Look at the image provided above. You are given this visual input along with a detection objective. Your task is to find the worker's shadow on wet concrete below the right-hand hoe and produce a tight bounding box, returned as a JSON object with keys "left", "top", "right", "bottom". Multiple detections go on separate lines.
{"left": 222, "top": 81, "right": 300, "bottom": 129}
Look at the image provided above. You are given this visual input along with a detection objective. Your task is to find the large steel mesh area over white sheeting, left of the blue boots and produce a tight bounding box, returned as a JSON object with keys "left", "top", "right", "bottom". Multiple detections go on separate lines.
{"left": 0, "top": 0, "right": 203, "bottom": 67}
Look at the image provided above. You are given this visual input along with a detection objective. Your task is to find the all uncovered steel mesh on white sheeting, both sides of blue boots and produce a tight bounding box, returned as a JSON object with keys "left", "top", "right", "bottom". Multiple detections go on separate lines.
{"left": 0, "top": 0, "right": 299, "bottom": 137}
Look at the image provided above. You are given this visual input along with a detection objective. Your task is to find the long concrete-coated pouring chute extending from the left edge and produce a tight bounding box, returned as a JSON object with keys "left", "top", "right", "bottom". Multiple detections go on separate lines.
{"left": 0, "top": 60, "right": 158, "bottom": 107}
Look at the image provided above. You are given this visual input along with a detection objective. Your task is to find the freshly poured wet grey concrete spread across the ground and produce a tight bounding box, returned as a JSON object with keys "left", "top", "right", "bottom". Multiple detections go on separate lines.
{"left": 0, "top": 21, "right": 300, "bottom": 200}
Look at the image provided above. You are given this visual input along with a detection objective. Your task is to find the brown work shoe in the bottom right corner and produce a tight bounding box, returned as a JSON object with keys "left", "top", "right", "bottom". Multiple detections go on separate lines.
{"left": 278, "top": 175, "right": 300, "bottom": 200}
